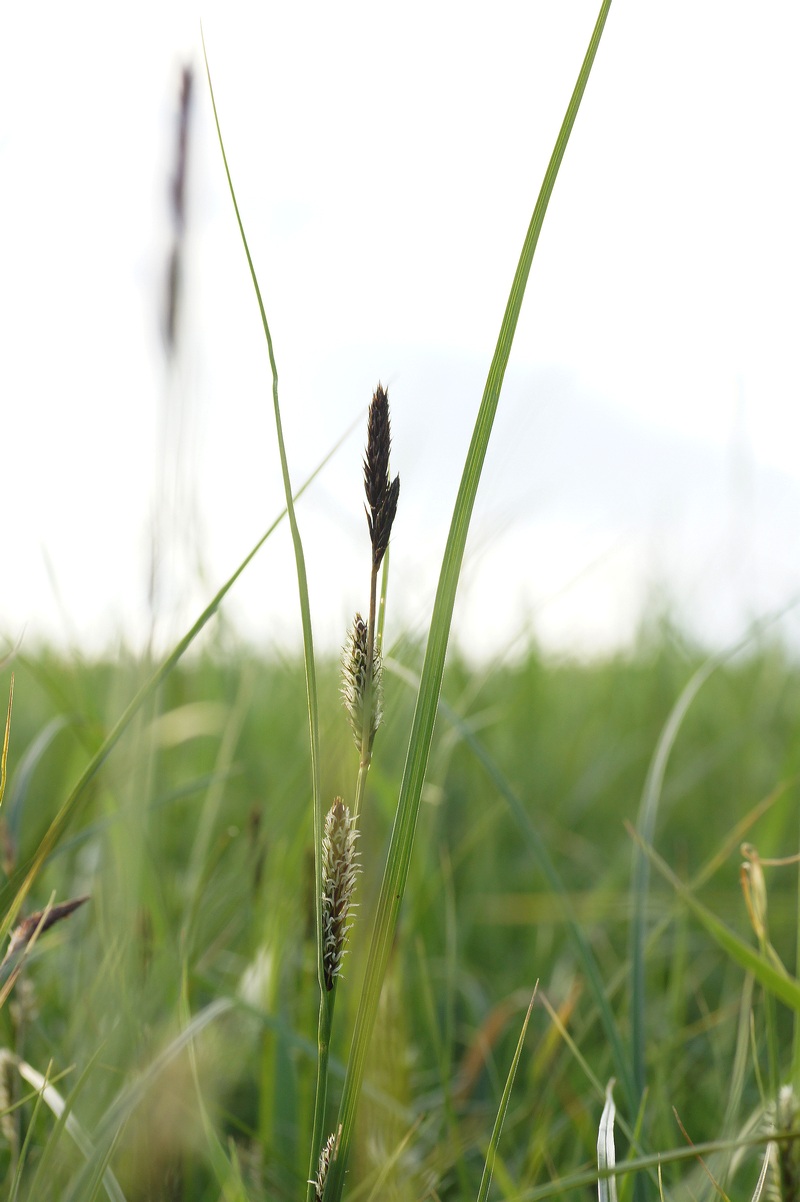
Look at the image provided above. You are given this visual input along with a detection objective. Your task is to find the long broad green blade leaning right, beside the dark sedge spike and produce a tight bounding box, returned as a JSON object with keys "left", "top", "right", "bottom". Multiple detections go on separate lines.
{"left": 326, "top": 7, "right": 610, "bottom": 1202}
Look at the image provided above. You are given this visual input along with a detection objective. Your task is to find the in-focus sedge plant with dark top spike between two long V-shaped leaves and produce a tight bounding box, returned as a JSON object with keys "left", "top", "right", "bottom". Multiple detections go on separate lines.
{"left": 207, "top": 0, "right": 610, "bottom": 1202}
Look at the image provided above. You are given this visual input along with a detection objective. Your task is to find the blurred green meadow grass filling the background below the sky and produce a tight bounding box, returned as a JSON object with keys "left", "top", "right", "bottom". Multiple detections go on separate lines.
{"left": 0, "top": 632, "right": 800, "bottom": 1200}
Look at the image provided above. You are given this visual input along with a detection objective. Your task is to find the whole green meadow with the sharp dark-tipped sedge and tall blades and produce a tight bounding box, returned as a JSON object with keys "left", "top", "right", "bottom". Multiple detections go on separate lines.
{"left": 0, "top": 0, "right": 800, "bottom": 1202}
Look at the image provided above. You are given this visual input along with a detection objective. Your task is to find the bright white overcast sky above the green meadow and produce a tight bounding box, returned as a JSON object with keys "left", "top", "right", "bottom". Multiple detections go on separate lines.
{"left": 0, "top": 0, "right": 800, "bottom": 653}
